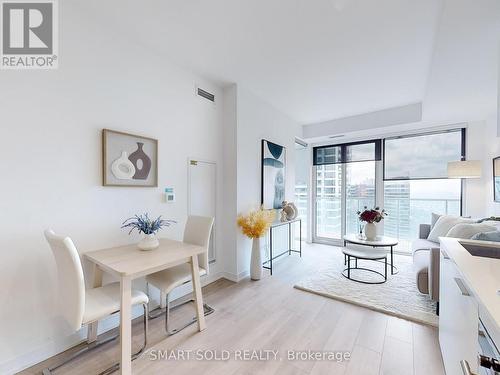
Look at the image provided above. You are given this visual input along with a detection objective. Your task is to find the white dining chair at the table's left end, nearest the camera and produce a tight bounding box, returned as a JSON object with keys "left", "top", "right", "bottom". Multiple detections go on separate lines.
{"left": 43, "top": 229, "right": 149, "bottom": 375}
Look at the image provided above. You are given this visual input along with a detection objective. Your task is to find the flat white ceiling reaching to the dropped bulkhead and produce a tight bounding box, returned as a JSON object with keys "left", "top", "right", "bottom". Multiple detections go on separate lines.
{"left": 80, "top": 0, "right": 442, "bottom": 124}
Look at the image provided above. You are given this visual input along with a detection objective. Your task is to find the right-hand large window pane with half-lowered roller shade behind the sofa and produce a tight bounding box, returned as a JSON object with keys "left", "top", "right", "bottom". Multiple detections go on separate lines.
{"left": 384, "top": 130, "right": 465, "bottom": 252}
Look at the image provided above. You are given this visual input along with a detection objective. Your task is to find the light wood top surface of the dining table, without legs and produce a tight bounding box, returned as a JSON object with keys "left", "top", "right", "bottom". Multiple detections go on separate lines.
{"left": 83, "top": 238, "right": 206, "bottom": 278}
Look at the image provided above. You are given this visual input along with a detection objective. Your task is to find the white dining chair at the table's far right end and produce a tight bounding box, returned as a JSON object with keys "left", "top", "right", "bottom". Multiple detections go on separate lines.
{"left": 146, "top": 216, "right": 214, "bottom": 336}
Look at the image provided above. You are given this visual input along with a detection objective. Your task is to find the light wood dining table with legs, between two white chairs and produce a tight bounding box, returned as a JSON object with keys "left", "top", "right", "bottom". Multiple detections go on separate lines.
{"left": 83, "top": 239, "right": 206, "bottom": 374}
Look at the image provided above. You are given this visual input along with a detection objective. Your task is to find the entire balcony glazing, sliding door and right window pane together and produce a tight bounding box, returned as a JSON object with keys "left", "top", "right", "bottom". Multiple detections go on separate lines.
{"left": 313, "top": 129, "right": 465, "bottom": 252}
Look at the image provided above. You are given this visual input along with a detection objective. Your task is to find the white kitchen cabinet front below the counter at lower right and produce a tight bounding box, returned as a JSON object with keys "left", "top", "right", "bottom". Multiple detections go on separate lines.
{"left": 439, "top": 247, "right": 479, "bottom": 375}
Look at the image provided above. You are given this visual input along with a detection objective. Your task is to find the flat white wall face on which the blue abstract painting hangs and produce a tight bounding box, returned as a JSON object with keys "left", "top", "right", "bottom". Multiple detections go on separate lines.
{"left": 237, "top": 86, "right": 300, "bottom": 278}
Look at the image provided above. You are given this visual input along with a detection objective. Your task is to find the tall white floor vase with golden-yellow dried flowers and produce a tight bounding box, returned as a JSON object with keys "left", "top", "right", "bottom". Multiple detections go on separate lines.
{"left": 237, "top": 208, "right": 276, "bottom": 280}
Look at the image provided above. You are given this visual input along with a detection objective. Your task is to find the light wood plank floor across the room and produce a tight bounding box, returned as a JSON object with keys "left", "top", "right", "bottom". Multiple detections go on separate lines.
{"left": 23, "top": 245, "right": 444, "bottom": 375}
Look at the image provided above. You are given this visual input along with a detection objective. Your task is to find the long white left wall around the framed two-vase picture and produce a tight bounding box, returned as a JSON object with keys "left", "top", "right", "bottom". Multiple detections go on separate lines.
{"left": 0, "top": 0, "right": 224, "bottom": 373}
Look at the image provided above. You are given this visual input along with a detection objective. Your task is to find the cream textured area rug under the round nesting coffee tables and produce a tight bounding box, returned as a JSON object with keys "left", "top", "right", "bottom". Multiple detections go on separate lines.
{"left": 294, "top": 249, "right": 438, "bottom": 326}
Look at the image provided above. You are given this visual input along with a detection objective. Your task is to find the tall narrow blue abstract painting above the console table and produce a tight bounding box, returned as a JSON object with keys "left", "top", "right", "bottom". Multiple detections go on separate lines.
{"left": 261, "top": 139, "right": 286, "bottom": 209}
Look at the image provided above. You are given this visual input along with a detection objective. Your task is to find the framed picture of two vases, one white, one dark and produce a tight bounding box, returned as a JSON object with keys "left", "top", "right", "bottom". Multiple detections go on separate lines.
{"left": 102, "top": 129, "right": 158, "bottom": 187}
